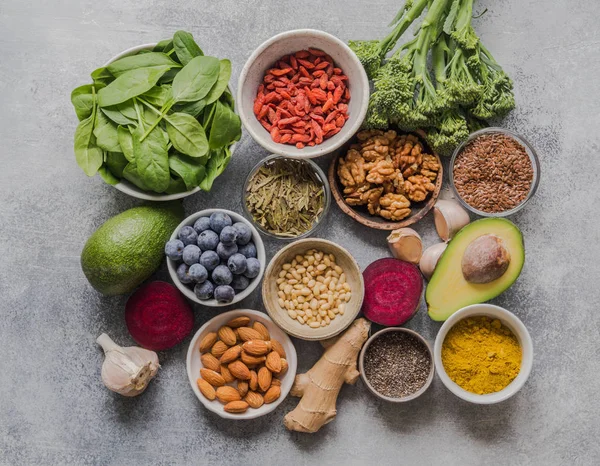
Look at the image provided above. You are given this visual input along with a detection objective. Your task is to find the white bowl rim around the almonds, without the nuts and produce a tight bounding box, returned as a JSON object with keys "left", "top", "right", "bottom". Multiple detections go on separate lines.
{"left": 185, "top": 309, "right": 298, "bottom": 421}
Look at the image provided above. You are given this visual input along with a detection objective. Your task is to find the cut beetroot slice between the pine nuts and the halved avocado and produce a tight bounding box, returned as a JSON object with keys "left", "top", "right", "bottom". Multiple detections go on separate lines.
{"left": 362, "top": 258, "right": 423, "bottom": 326}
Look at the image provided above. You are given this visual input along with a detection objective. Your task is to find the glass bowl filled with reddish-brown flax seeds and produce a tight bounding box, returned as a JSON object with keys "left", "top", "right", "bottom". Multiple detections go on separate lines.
{"left": 449, "top": 128, "right": 540, "bottom": 217}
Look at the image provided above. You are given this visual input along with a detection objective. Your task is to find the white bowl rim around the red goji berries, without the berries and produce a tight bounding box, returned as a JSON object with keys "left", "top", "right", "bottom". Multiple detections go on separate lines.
{"left": 237, "top": 29, "right": 370, "bottom": 159}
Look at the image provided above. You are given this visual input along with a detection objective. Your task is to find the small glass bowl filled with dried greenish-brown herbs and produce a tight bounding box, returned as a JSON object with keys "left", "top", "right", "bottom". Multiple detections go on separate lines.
{"left": 242, "top": 155, "right": 331, "bottom": 239}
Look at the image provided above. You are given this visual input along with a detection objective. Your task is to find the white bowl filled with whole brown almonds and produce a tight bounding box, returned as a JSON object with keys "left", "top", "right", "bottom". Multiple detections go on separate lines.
{"left": 187, "top": 309, "right": 298, "bottom": 419}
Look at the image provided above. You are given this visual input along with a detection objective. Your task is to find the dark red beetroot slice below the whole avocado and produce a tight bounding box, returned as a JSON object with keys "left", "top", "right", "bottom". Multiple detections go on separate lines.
{"left": 125, "top": 282, "right": 194, "bottom": 351}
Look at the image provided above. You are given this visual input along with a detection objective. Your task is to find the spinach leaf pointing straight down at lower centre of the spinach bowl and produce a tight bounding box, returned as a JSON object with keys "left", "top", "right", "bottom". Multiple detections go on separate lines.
{"left": 132, "top": 127, "right": 170, "bottom": 193}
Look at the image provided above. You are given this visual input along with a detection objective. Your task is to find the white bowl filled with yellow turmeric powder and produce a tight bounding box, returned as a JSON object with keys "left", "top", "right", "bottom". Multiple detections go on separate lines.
{"left": 433, "top": 304, "right": 533, "bottom": 404}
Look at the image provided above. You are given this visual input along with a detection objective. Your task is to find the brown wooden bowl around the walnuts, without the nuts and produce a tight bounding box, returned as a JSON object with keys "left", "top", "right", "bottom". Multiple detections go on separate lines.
{"left": 327, "top": 129, "right": 444, "bottom": 230}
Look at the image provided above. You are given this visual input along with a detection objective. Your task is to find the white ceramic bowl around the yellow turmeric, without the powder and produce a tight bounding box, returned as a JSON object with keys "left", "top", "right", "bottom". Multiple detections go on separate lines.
{"left": 433, "top": 304, "right": 533, "bottom": 405}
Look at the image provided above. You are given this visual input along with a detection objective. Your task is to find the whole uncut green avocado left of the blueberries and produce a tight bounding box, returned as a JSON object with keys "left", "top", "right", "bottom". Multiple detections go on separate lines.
{"left": 81, "top": 202, "right": 184, "bottom": 296}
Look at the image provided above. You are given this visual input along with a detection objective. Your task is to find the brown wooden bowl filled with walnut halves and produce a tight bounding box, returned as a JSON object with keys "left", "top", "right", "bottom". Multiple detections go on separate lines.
{"left": 328, "top": 129, "right": 443, "bottom": 230}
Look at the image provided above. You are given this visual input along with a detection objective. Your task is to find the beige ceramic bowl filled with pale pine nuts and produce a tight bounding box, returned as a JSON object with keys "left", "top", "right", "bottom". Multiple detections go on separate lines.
{"left": 262, "top": 238, "right": 365, "bottom": 340}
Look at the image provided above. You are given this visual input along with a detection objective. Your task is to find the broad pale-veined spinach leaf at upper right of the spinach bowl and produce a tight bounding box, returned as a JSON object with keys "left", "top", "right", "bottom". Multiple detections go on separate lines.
{"left": 173, "top": 57, "right": 220, "bottom": 102}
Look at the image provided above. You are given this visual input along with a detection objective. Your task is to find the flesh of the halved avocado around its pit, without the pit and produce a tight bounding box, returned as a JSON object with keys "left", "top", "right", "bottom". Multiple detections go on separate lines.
{"left": 425, "top": 218, "right": 525, "bottom": 321}
